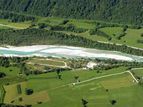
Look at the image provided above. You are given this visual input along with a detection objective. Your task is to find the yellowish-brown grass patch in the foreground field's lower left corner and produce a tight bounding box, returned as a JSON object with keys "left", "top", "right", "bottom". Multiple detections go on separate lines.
{"left": 4, "top": 82, "right": 49, "bottom": 105}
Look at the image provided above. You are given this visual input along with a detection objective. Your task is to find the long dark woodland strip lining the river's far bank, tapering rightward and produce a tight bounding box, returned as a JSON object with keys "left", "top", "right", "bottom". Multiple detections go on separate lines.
{"left": 0, "top": 28, "right": 143, "bottom": 56}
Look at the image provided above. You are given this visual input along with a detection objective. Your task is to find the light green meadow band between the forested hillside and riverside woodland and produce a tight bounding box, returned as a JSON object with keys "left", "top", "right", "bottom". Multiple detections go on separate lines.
{"left": 0, "top": 17, "right": 143, "bottom": 48}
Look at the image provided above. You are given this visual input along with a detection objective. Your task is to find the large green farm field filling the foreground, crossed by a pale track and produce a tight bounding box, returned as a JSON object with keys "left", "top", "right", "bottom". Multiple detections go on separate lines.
{"left": 0, "top": 62, "right": 143, "bottom": 107}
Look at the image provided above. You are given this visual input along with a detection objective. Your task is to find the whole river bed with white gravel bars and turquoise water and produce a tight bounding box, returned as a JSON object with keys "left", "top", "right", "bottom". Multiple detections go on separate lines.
{"left": 0, "top": 45, "right": 143, "bottom": 62}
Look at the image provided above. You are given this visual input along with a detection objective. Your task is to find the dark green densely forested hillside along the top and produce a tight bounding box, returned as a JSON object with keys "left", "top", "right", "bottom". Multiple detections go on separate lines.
{"left": 0, "top": 0, "right": 143, "bottom": 25}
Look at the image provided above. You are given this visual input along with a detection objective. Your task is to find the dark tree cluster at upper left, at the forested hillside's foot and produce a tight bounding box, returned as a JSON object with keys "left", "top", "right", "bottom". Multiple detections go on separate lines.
{"left": 0, "top": 11, "right": 35, "bottom": 22}
